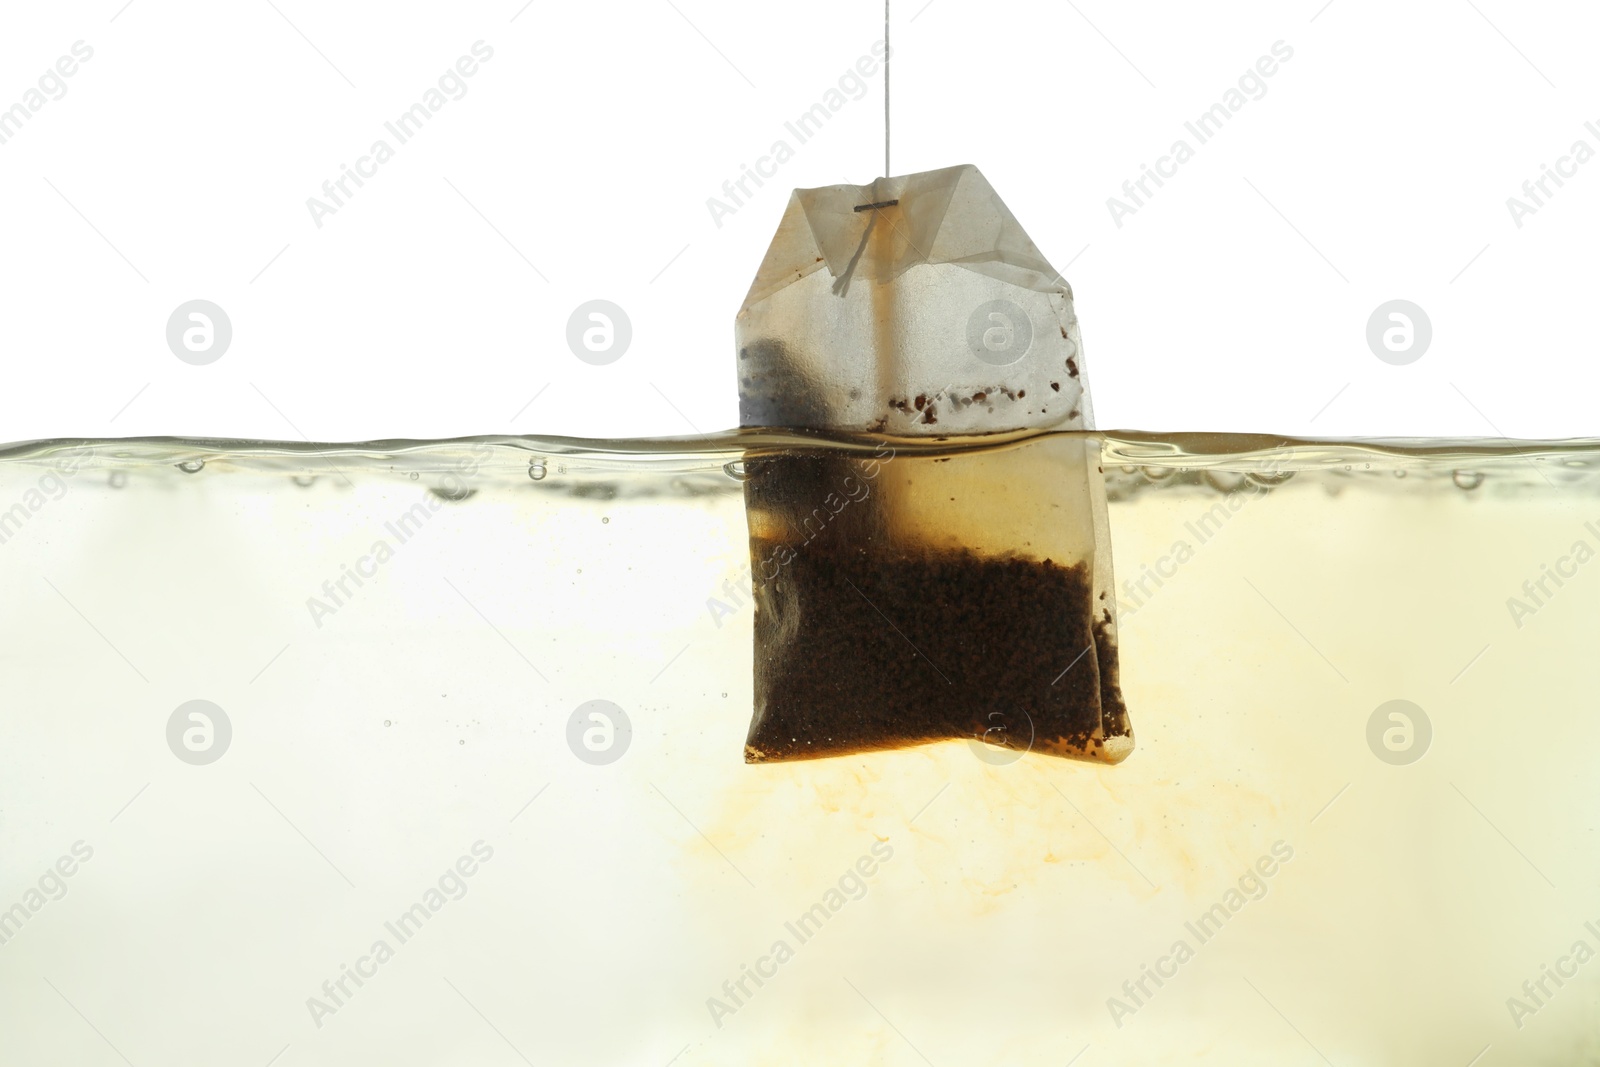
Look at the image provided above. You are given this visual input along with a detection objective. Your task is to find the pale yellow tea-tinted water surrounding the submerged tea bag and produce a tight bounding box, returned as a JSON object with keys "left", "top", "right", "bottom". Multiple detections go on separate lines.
{"left": 0, "top": 434, "right": 1600, "bottom": 1067}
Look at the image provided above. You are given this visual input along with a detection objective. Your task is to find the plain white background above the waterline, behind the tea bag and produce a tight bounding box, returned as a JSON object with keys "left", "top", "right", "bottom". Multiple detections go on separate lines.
{"left": 0, "top": 0, "right": 1600, "bottom": 440}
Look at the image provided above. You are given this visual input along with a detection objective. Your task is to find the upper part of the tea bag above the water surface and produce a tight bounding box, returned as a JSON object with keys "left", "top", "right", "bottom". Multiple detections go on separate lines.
{"left": 734, "top": 165, "right": 1093, "bottom": 435}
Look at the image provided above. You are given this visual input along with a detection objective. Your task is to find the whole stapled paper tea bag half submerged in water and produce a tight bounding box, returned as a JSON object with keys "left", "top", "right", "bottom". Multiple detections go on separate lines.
{"left": 734, "top": 166, "right": 1133, "bottom": 763}
